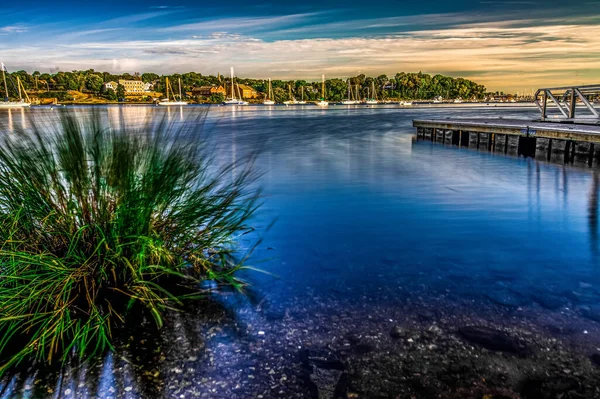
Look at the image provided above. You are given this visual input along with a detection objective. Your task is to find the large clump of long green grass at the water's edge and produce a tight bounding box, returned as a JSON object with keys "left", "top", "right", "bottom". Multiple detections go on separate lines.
{"left": 0, "top": 112, "right": 258, "bottom": 374}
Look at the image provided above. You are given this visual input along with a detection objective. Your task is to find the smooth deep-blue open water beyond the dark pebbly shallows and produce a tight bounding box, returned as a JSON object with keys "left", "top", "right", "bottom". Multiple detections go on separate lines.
{"left": 0, "top": 106, "right": 600, "bottom": 306}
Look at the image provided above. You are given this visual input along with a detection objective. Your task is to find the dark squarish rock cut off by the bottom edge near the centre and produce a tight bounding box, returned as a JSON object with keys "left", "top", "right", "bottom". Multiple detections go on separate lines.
{"left": 300, "top": 349, "right": 348, "bottom": 399}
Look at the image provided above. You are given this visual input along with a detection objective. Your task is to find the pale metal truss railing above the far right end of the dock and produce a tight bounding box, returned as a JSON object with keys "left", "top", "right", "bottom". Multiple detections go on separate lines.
{"left": 534, "top": 84, "right": 600, "bottom": 123}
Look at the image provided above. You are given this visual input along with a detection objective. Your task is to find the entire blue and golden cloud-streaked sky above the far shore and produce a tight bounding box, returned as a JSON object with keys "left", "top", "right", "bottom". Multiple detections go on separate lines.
{"left": 0, "top": 0, "right": 600, "bottom": 92}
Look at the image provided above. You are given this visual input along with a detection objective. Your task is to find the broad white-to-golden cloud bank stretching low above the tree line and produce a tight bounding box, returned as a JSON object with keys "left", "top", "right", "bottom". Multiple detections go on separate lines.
{"left": 0, "top": 14, "right": 600, "bottom": 91}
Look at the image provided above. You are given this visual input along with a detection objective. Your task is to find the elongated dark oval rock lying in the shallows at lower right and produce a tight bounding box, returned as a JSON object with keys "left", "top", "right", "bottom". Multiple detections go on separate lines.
{"left": 458, "top": 326, "right": 531, "bottom": 356}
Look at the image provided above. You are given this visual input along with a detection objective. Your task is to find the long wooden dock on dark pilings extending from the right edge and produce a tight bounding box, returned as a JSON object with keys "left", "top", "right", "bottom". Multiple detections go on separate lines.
{"left": 413, "top": 118, "right": 600, "bottom": 166}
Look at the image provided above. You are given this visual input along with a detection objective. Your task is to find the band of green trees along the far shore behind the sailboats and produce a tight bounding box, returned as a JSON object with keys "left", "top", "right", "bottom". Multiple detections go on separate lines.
{"left": 4, "top": 69, "right": 489, "bottom": 102}
